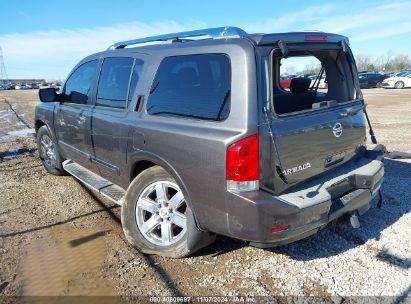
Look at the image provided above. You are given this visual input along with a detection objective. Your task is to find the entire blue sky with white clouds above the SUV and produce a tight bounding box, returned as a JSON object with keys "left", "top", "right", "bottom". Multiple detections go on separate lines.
{"left": 0, "top": 0, "right": 411, "bottom": 80}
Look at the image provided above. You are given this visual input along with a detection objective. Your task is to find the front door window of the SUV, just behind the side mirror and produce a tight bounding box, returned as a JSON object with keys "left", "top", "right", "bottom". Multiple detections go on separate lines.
{"left": 64, "top": 60, "right": 97, "bottom": 103}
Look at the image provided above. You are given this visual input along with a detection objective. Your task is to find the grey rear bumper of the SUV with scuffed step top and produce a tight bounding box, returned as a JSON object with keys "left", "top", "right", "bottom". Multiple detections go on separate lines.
{"left": 227, "top": 151, "right": 384, "bottom": 247}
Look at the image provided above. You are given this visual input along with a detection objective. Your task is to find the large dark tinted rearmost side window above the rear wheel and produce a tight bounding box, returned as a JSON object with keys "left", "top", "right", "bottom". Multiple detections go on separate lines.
{"left": 147, "top": 54, "right": 231, "bottom": 121}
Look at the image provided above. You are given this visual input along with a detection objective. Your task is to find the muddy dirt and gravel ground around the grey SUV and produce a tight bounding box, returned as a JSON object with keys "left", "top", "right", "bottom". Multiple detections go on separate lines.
{"left": 0, "top": 89, "right": 411, "bottom": 302}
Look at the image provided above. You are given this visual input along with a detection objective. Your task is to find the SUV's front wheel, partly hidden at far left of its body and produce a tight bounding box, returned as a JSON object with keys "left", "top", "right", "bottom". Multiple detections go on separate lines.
{"left": 37, "top": 126, "right": 65, "bottom": 175}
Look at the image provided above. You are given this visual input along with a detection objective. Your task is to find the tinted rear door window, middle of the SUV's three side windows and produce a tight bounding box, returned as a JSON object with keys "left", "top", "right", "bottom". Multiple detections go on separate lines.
{"left": 96, "top": 57, "right": 134, "bottom": 108}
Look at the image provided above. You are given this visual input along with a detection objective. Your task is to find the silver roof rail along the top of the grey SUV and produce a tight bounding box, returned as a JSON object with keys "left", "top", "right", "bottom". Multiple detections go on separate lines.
{"left": 108, "top": 26, "right": 247, "bottom": 50}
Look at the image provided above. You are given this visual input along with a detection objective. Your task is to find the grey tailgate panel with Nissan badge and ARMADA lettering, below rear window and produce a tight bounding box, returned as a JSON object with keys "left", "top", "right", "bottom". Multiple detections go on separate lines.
{"left": 270, "top": 102, "right": 366, "bottom": 190}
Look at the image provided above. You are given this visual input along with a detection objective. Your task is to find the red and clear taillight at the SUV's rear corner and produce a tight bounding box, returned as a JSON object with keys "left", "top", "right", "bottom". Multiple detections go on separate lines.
{"left": 226, "top": 134, "right": 259, "bottom": 191}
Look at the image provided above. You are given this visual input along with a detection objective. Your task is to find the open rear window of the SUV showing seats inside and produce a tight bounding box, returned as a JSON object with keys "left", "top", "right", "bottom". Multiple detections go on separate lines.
{"left": 271, "top": 49, "right": 357, "bottom": 115}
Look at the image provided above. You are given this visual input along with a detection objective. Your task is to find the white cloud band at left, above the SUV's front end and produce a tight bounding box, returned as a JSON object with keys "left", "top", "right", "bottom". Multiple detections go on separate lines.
{"left": 0, "top": 21, "right": 206, "bottom": 79}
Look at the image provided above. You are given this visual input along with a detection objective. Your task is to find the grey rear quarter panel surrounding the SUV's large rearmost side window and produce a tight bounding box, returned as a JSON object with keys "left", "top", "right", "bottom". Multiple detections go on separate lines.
{"left": 127, "top": 39, "right": 258, "bottom": 234}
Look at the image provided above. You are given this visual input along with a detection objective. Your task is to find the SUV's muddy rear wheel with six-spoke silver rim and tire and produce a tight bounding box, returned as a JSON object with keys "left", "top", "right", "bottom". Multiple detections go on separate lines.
{"left": 121, "top": 166, "right": 212, "bottom": 258}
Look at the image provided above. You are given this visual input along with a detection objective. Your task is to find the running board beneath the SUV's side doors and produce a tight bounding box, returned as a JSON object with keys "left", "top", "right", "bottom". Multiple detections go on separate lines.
{"left": 63, "top": 159, "right": 126, "bottom": 205}
